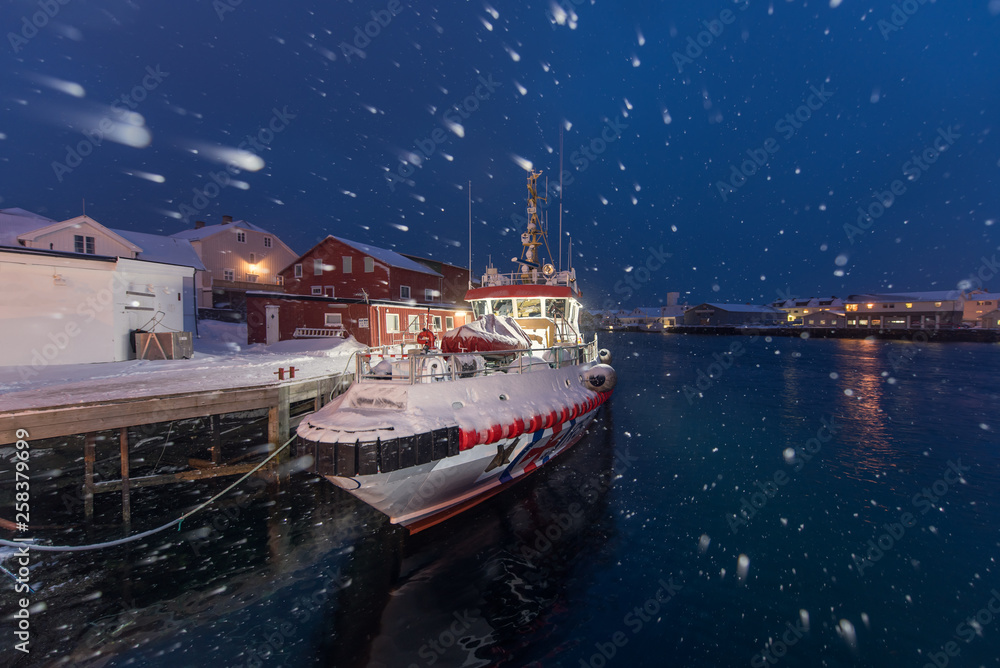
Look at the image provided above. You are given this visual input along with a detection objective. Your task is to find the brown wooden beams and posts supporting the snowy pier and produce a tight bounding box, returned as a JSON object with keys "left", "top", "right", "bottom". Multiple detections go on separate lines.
{"left": 0, "top": 374, "right": 353, "bottom": 524}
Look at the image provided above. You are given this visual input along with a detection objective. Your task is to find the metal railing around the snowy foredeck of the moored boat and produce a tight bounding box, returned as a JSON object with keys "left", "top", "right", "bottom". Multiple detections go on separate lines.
{"left": 354, "top": 336, "right": 598, "bottom": 385}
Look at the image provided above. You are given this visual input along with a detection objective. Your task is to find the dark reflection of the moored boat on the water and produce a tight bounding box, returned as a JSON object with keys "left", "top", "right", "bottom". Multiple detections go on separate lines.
{"left": 368, "top": 404, "right": 623, "bottom": 666}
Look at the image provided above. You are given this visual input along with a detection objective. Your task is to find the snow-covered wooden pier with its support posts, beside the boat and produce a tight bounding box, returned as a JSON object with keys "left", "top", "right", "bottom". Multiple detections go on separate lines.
{"left": 0, "top": 328, "right": 359, "bottom": 523}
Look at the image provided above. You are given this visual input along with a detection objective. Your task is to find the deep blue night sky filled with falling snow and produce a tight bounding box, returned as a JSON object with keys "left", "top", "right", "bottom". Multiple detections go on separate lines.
{"left": 0, "top": 0, "right": 1000, "bottom": 308}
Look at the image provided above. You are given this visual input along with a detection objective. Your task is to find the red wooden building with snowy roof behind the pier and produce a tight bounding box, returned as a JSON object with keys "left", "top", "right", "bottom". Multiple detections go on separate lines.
{"left": 247, "top": 236, "right": 472, "bottom": 346}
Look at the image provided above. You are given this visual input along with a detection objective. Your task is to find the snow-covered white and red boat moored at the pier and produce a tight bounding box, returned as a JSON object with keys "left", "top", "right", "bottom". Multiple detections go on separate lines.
{"left": 296, "top": 171, "right": 616, "bottom": 533}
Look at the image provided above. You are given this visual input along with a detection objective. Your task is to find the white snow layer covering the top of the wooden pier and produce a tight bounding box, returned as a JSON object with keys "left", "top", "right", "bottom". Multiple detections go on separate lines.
{"left": 0, "top": 321, "right": 363, "bottom": 411}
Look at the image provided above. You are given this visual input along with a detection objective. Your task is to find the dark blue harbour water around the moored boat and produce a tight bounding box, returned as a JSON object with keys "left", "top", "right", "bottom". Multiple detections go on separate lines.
{"left": 0, "top": 334, "right": 1000, "bottom": 668}
